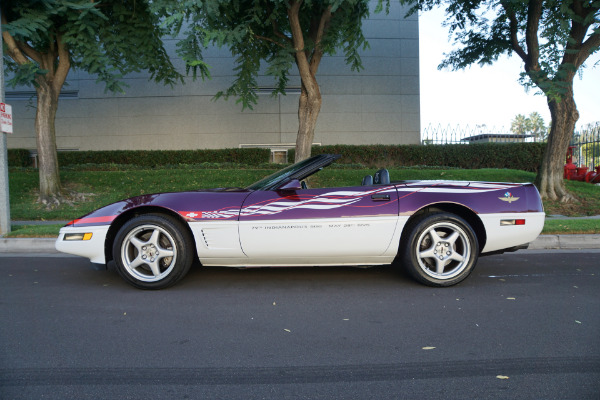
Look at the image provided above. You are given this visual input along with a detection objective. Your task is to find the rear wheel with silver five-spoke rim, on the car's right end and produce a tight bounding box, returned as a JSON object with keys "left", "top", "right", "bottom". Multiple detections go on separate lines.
{"left": 400, "top": 212, "right": 479, "bottom": 287}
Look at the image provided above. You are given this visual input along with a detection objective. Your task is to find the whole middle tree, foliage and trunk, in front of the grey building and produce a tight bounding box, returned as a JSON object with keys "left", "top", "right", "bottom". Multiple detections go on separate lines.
{"left": 153, "top": 0, "right": 389, "bottom": 160}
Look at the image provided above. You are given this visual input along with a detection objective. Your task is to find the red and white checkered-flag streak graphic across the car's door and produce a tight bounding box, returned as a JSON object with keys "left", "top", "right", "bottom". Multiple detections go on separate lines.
{"left": 179, "top": 186, "right": 396, "bottom": 219}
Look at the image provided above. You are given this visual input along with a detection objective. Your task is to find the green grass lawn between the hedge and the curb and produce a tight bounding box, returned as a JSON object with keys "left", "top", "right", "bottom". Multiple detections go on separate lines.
{"left": 9, "top": 168, "right": 600, "bottom": 236}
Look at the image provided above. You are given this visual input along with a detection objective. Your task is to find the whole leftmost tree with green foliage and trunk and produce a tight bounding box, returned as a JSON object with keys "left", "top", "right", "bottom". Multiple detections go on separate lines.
{"left": 1, "top": 0, "right": 181, "bottom": 202}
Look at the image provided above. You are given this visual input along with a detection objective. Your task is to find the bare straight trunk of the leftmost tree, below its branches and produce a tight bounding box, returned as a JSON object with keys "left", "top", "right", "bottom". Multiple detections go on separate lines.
{"left": 35, "top": 78, "right": 62, "bottom": 204}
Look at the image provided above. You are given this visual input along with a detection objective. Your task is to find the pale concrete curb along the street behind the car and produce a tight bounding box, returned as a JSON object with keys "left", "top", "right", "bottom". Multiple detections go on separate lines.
{"left": 0, "top": 234, "right": 600, "bottom": 254}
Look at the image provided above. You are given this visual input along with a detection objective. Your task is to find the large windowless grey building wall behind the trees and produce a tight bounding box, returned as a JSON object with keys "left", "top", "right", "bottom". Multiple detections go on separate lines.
{"left": 6, "top": 2, "right": 420, "bottom": 150}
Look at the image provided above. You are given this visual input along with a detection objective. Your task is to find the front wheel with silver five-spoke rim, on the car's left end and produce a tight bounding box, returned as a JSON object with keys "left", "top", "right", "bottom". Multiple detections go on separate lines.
{"left": 113, "top": 214, "right": 194, "bottom": 289}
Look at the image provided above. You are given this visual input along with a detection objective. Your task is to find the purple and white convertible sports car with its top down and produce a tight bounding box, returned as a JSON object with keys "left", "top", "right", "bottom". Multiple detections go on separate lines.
{"left": 56, "top": 154, "right": 545, "bottom": 289}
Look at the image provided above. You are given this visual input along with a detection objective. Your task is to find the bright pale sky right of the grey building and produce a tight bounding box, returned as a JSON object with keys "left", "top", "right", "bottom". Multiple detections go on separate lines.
{"left": 419, "top": 9, "right": 600, "bottom": 130}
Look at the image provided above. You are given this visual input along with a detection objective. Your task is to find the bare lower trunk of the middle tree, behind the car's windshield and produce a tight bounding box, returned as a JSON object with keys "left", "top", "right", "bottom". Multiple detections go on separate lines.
{"left": 295, "top": 80, "right": 322, "bottom": 162}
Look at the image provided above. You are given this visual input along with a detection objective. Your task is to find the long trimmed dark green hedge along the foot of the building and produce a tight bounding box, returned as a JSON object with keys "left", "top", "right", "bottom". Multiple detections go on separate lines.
{"left": 8, "top": 143, "right": 546, "bottom": 172}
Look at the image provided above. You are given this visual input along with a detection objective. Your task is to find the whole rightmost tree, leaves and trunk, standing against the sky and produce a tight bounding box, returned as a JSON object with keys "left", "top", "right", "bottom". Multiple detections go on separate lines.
{"left": 401, "top": 0, "right": 600, "bottom": 201}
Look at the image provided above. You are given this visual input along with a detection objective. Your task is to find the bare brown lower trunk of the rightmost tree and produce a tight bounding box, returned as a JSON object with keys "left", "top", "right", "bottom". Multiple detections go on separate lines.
{"left": 536, "top": 86, "right": 579, "bottom": 202}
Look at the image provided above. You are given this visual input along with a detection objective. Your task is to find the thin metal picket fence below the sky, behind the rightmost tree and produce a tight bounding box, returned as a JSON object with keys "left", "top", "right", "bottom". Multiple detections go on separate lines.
{"left": 421, "top": 122, "right": 600, "bottom": 171}
